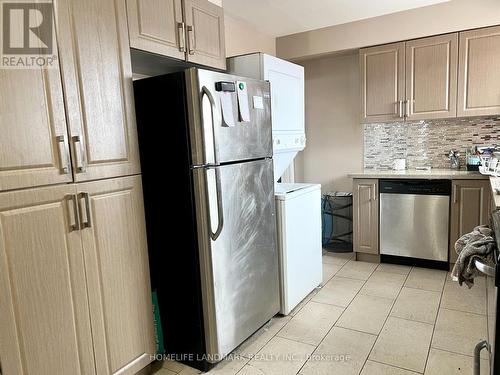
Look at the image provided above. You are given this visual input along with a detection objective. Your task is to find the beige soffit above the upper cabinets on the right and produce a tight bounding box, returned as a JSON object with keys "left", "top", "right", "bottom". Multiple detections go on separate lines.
{"left": 278, "top": 0, "right": 500, "bottom": 59}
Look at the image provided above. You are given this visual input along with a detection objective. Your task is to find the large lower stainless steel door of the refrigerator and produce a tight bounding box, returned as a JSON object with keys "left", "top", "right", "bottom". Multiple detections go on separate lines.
{"left": 193, "top": 159, "right": 280, "bottom": 362}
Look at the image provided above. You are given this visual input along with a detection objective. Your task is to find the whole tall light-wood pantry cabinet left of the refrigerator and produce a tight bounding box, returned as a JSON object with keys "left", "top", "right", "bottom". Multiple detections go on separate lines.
{"left": 0, "top": 0, "right": 155, "bottom": 375}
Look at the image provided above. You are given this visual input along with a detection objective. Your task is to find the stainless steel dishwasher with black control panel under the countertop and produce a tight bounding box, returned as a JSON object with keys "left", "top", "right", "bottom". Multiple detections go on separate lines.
{"left": 379, "top": 179, "right": 451, "bottom": 269}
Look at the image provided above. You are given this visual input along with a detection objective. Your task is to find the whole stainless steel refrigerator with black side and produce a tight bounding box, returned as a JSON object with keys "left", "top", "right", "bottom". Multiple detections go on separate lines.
{"left": 134, "top": 68, "right": 279, "bottom": 370}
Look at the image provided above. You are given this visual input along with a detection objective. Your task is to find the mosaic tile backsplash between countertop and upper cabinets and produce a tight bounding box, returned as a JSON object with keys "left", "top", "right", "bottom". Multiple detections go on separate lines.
{"left": 364, "top": 116, "right": 500, "bottom": 169}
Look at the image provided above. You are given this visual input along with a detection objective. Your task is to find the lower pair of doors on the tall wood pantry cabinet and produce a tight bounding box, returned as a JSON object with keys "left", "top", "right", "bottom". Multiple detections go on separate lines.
{"left": 0, "top": 176, "right": 155, "bottom": 375}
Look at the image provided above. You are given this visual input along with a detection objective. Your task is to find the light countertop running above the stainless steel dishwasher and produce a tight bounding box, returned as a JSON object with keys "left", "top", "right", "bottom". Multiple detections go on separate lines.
{"left": 348, "top": 169, "right": 488, "bottom": 180}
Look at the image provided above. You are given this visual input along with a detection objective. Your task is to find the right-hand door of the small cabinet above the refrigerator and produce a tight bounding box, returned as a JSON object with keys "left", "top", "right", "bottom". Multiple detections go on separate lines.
{"left": 184, "top": 0, "right": 226, "bottom": 69}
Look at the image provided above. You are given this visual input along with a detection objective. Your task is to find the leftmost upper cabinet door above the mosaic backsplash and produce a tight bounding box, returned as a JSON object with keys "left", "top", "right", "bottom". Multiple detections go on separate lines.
{"left": 360, "top": 43, "right": 405, "bottom": 123}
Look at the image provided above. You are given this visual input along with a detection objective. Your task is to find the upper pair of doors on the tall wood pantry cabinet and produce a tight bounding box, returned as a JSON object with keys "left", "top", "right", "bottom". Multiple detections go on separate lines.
{"left": 0, "top": 0, "right": 140, "bottom": 191}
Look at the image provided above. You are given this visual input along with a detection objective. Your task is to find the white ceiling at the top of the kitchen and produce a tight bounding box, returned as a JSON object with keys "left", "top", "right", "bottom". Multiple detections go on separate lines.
{"left": 224, "top": 0, "right": 449, "bottom": 37}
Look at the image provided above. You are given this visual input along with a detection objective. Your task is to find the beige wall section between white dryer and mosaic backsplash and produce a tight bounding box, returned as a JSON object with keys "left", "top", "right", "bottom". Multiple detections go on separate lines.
{"left": 295, "top": 53, "right": 363, "bottom": 192}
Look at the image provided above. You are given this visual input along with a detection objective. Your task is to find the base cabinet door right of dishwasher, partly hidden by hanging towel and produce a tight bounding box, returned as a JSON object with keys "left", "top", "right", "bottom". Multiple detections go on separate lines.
{"left": 450, "top": 180, "right": 491, "bottom": 263}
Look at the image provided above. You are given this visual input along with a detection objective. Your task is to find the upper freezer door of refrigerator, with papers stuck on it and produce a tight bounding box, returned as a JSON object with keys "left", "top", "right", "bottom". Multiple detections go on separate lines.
{"left": 186, "top": 69, "right": 272, "bottom": 166}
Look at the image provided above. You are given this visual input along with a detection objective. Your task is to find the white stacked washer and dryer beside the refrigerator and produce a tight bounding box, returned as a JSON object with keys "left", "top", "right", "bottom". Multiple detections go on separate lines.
{"left": 228, "top": 53, "right": 322, "bottom": 315}
